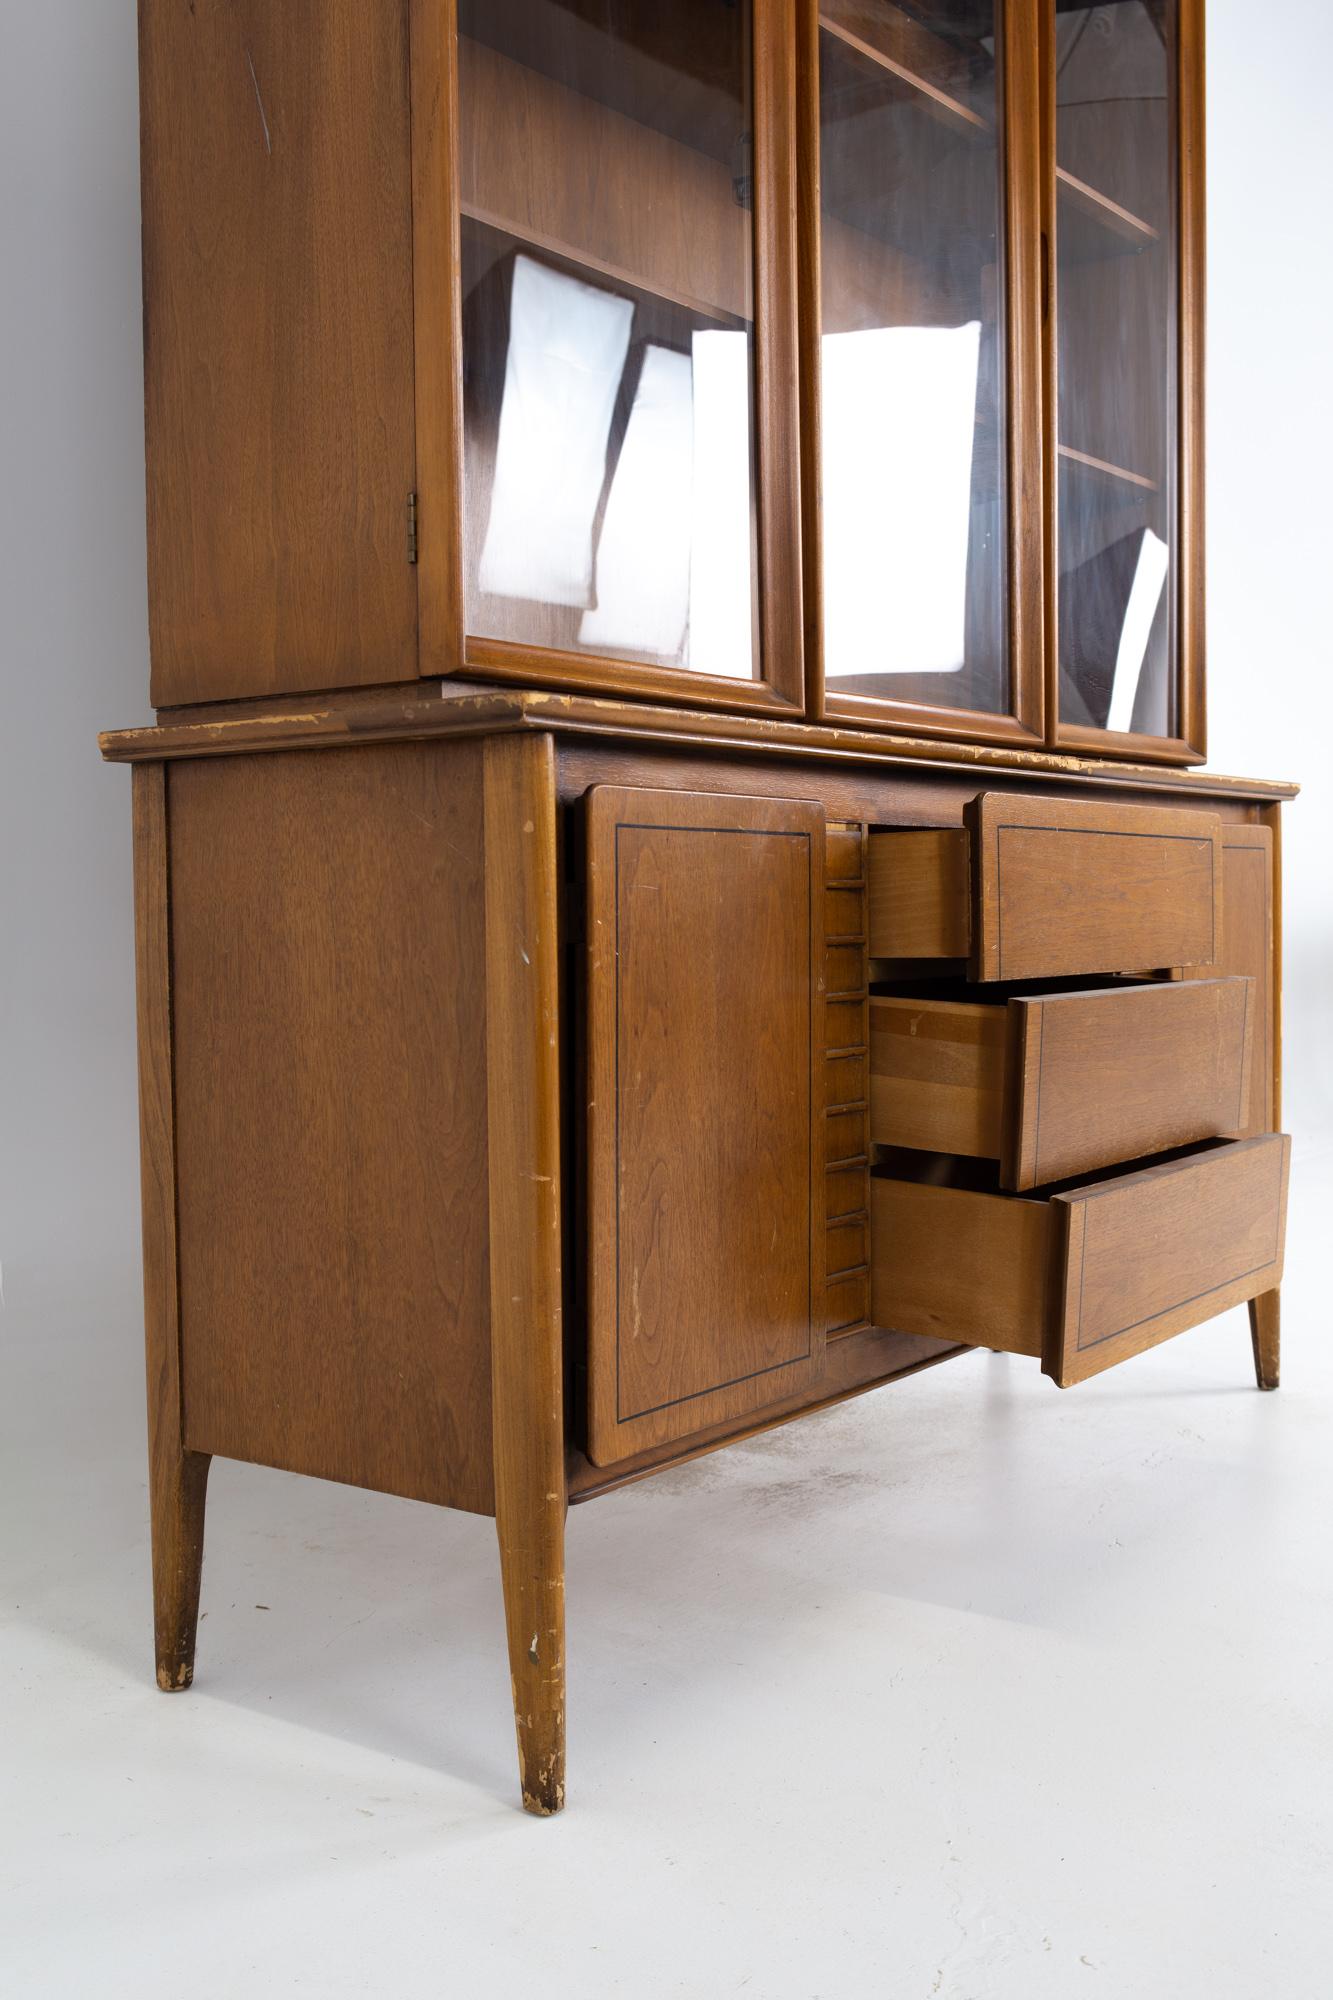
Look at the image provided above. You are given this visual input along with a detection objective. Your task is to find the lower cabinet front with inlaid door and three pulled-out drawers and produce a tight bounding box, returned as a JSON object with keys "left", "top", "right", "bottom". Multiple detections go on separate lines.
{"left": 582, "top": 784, "right": 1289, "bottom": 1466}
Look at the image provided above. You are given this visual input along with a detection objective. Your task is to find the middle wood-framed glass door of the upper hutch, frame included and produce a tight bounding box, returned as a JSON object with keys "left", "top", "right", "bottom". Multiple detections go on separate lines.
{"left": 807, "top": 0, "right": 1043, "bottom": 742}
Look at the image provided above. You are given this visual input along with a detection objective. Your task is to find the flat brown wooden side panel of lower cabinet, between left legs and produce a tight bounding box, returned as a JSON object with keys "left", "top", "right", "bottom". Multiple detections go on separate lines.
{"left": 170, "top": 744, "right": 492, "bottom": 1512}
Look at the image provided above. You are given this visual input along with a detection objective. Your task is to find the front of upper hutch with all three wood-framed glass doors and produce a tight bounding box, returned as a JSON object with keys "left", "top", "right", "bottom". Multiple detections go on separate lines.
{"left": 430, "top": 0, "right": 1203, "bottom": 762}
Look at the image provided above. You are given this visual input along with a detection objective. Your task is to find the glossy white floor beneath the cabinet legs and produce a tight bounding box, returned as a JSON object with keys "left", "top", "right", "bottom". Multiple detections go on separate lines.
{"left": 0, "top": 1160, "right": 1333, "bottom": 2000}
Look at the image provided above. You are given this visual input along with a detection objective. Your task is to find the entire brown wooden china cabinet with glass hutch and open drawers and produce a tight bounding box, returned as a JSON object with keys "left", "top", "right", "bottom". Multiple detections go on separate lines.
{"left": 102, "top": 0, "right": 1293, "bottom": 1812}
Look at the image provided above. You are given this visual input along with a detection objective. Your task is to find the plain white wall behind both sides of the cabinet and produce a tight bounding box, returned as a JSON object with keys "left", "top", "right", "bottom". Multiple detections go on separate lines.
{"left": 0, "top": 0, "right": 1333, "bottom": 1300}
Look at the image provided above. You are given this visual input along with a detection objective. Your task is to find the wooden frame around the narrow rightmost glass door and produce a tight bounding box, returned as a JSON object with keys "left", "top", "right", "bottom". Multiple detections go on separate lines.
{"left": 1041, "top": 0, "right": 1207, "bottom": 764}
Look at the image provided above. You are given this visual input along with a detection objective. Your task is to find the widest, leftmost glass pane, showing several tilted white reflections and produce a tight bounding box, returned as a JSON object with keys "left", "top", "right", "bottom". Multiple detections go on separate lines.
{"left": 458, "top": 0, "right": 759, "bottom": 680}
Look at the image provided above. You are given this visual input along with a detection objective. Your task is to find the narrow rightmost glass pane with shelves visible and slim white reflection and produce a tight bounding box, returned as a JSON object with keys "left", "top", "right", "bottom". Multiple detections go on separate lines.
{"left": 1055, "top": 0, "right": 1175, "bottom": 736}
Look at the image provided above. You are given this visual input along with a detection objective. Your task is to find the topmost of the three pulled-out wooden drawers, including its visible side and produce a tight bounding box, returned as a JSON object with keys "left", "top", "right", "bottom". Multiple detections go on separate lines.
{"left": 867, "top": 792, "right": 1221, "bottom": 980}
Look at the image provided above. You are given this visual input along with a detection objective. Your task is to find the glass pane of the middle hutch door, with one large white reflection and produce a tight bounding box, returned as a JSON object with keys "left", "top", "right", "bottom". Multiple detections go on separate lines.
{"left": 819, "top": 0, "right": 1009, "bottom": 714}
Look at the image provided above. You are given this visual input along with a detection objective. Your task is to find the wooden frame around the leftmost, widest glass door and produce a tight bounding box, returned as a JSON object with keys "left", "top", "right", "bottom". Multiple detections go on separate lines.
{"left": 410, "top": 0, "right": 805, "bottom": 716}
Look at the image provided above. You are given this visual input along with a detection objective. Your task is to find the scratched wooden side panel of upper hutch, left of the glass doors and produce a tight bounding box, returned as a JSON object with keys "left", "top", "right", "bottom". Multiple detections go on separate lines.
{"left": 140, "top": 0, "right": 416, "bottom": 706}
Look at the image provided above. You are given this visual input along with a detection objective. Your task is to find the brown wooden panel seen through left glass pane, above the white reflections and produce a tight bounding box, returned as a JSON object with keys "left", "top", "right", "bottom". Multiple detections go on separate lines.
{"left": 458, "top": 36, "right": 755, "bottom": 326}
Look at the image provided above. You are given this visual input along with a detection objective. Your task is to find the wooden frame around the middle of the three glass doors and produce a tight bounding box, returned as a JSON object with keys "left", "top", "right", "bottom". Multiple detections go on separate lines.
{"left": 801, "top": 0, "right": 1047, "bottom": 746}
